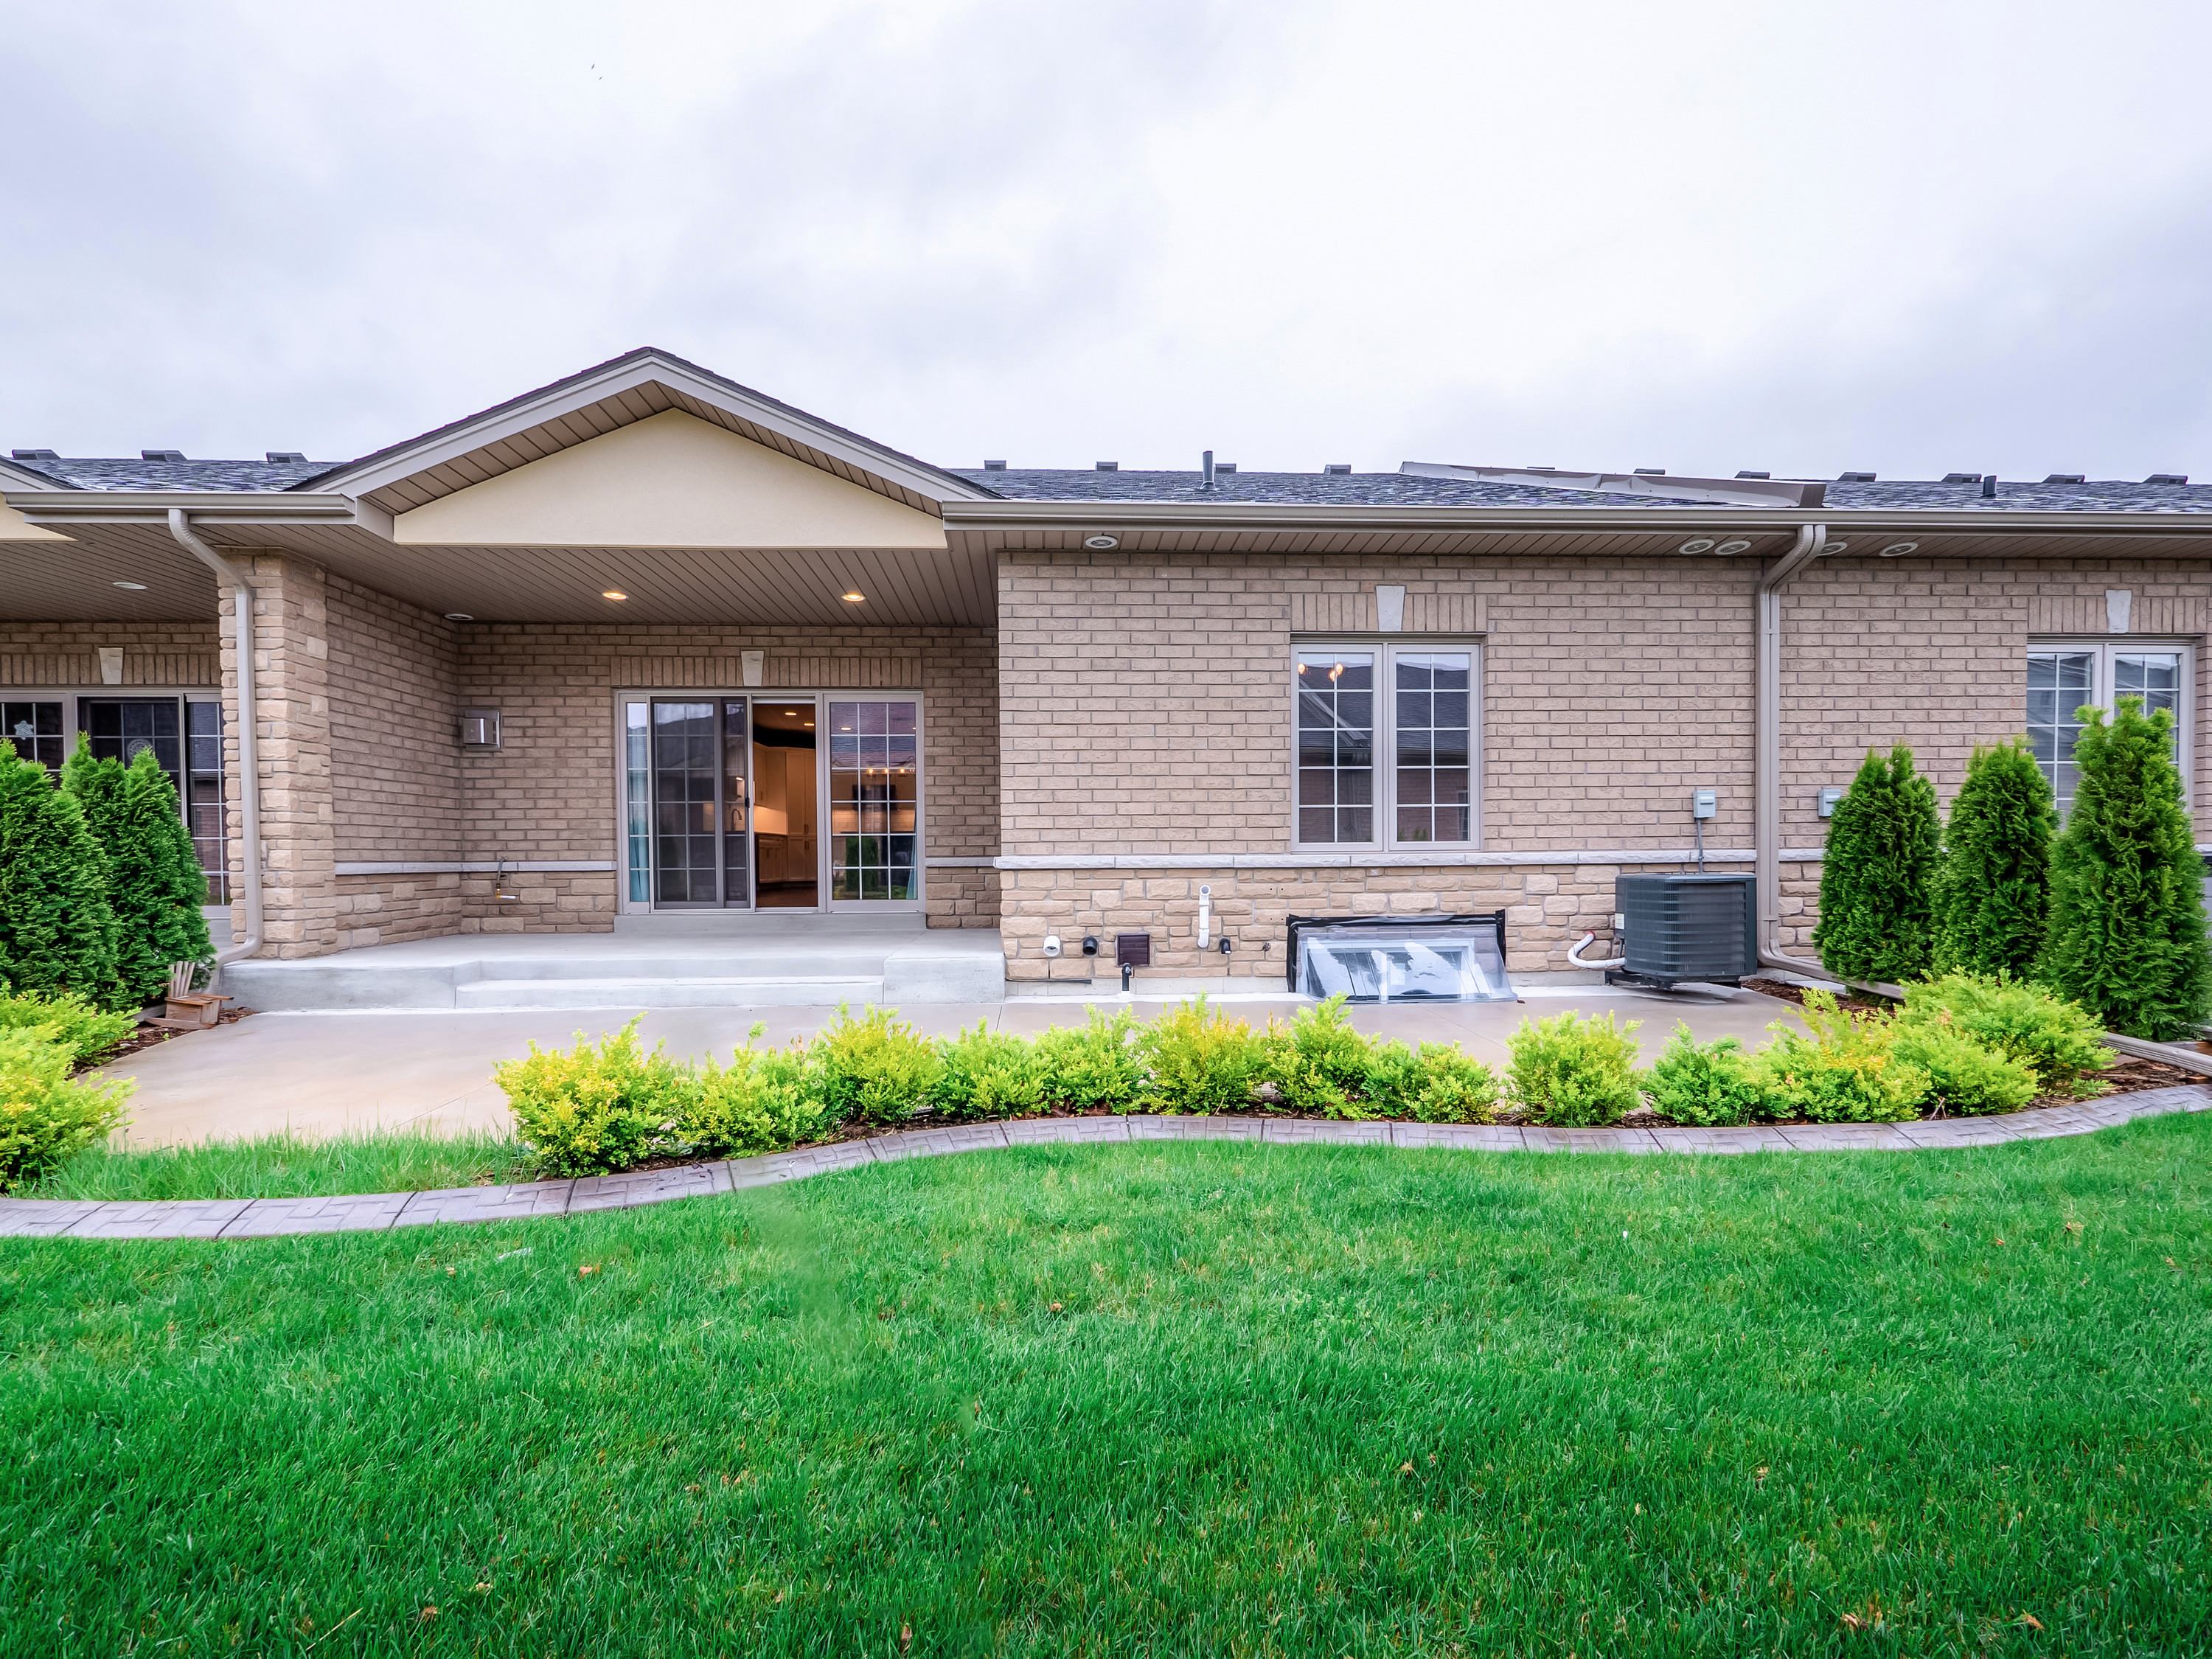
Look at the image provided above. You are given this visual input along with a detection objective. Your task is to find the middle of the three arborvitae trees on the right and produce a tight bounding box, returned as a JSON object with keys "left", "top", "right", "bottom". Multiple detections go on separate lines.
{"left": 1935, "top": 739, "right": 2057, "bottom": 978}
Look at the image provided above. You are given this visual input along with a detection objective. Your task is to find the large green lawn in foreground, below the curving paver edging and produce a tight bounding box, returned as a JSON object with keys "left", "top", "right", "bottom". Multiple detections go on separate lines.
{"left": 0, "top": 1119, "right": 2212, "bottom": 1657}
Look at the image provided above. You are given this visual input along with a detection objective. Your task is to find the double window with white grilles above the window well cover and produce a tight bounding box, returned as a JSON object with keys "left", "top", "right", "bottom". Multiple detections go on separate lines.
{"left": 1292, "top": 641, "right": 1482, "bottom": 847}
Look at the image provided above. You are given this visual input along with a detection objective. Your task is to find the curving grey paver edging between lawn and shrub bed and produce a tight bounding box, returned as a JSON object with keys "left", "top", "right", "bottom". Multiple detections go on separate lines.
{"left": 0, "top": 1084, "right": 2212, "bottom": 1239}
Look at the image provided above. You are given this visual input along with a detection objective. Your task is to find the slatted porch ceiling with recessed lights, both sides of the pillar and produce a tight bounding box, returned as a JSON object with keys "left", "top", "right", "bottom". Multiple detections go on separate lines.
{"left": 0, "top": 524, "right": 998, "bottom": 628}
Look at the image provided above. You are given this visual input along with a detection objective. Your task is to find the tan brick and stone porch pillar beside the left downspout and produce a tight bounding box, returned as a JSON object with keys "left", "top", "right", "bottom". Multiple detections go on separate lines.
{"left": 223, "top": 549, "right": 341, "bottom": 958}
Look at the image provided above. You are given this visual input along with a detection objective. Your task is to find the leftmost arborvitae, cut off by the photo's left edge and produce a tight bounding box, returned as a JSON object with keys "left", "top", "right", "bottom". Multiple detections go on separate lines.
{"left": 0, "top": 743, "right": 119, "bottom": 1004}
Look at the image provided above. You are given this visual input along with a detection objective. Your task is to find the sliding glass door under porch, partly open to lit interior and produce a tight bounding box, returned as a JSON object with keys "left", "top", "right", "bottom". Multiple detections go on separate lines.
{"left": 619, "top": 692, "right": 922, "bottom": 914}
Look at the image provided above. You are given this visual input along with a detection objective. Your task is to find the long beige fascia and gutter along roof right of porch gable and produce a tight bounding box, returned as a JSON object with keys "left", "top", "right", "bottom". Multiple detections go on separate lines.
{"left": 945, "top": 500, "right": 2212, "bottom": 538}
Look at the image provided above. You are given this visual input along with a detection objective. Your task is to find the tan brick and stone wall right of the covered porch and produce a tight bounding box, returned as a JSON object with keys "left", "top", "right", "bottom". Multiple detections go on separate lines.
{"left": 1000, "top": 553, "right": 2212, "bottom": 980}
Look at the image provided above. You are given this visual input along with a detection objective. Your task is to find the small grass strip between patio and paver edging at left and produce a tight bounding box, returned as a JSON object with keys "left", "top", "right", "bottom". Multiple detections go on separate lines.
{"left": 24, "top": 1130, "right": 531, "bottom": 1199}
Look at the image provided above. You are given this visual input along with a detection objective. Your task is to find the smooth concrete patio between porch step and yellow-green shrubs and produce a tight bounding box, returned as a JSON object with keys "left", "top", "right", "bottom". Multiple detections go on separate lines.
{"left": 95, "top": 982, "right": 1794, "bottom": 1146}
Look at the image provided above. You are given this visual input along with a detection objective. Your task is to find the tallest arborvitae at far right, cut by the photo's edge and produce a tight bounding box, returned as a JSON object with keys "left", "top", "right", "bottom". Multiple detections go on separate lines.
{"left": 2039, "top": 697, "right": 2212, "bottom": 1042}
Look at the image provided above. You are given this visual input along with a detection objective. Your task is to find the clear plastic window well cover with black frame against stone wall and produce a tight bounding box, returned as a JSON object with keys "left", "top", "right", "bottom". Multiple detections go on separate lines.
{"left": 1290, "top": 911, "right": 1515, "bottom": 1002}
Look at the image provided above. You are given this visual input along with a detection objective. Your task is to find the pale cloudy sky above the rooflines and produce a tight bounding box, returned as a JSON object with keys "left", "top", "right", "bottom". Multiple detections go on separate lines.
{"left": 0, "top": 0, "right": 2212, "bottom": 478}
